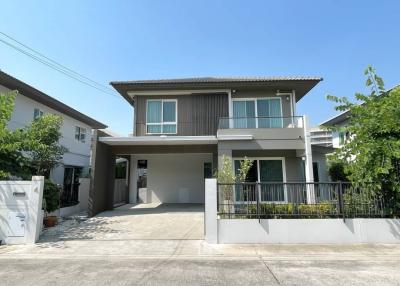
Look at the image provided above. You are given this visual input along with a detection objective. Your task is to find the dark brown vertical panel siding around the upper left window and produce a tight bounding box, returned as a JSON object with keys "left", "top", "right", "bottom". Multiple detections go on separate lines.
{"left": 134, "top": 93, "right": 229, "bottom": 136}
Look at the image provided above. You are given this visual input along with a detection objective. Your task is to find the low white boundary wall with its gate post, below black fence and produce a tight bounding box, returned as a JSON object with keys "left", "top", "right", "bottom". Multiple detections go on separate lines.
{"left": 205, "top": 179, "right": 400, "bottom": 244}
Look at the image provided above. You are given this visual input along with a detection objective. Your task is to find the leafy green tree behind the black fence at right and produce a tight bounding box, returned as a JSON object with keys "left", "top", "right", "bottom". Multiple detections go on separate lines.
{"left": 328, "top": 67, "right": 400, "bottom": 195}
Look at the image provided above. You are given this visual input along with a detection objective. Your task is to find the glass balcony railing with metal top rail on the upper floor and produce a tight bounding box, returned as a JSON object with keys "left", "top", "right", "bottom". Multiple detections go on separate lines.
{"left": 218, "top": 116, "right": 304, "bottom": 129}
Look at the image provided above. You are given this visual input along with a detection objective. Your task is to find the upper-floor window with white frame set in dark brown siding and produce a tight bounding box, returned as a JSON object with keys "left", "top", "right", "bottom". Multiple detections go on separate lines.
{"left": 146, "top": 99, "right": 177, "bottom": 134}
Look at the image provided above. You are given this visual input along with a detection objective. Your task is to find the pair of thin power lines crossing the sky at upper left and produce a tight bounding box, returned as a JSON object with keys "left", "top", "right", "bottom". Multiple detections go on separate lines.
{"left": 0, "top": 32, "right": 121, "bottom": 98}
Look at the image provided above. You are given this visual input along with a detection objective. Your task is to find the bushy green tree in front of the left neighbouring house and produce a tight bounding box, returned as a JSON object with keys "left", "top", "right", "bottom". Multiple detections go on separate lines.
{"left": 0, "top": 91, "right": 67, "bottom": 179}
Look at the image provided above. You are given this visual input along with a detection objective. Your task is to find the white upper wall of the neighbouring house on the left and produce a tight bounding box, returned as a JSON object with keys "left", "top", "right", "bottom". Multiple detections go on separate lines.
{"left": 0, "top": 85, "right": 92, "bottom": 184}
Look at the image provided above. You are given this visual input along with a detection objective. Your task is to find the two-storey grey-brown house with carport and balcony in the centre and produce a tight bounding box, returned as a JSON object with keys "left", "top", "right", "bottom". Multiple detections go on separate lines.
{"left": 90, "top": 77, "right": 322, "bottom": 215}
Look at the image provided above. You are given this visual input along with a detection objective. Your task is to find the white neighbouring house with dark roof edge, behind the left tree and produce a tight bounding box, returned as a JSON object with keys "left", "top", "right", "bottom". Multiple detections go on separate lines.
{"left": 0, "top": 71, "right": 107, "bottom": 208}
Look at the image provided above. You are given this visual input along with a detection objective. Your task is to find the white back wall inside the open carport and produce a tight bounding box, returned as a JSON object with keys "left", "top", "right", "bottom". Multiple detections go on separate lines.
{"left": 129, "top": 154, "right": 212, "bottom": 203}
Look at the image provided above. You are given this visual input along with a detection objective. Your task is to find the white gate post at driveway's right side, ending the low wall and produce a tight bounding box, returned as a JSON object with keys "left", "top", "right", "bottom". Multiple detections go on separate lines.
{"left": 204, "top": 179, "right": 218, "bottom": 244}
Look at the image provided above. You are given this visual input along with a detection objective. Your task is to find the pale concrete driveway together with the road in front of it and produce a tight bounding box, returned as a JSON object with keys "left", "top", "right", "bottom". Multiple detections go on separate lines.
{"left": 0, "top": 206, "right": 400, "bottom": 286}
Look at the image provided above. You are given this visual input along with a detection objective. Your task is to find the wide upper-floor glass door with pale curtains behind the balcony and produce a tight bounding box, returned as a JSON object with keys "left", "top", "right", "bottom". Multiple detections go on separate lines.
{"left": 233, "top": 98, "right": 283, "bottom": 128}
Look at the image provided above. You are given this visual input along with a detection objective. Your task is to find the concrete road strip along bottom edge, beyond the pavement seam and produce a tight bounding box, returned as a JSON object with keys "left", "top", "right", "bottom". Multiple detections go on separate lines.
{"left": 0, "top": 257, "right": 400, "bottom": 286}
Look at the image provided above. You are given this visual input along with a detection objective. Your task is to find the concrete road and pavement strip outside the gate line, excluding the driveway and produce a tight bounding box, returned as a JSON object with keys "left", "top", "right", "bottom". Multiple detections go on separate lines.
{"left": 0, "top": 240, "right": 400, "bottom": 286}
